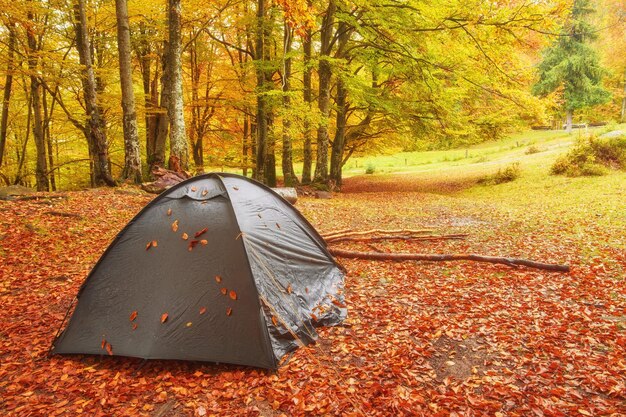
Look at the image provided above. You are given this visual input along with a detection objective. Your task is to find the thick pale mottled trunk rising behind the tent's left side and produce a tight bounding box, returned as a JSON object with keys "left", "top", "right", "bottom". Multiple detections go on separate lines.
{"left": 167, "top": 0, "right": 189, "bottom": 171}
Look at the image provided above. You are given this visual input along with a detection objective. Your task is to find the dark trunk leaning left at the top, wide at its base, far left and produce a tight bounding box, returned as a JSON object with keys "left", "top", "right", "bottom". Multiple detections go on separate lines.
{"left": 74, "top": 0, "right": 116, "bottom": 186}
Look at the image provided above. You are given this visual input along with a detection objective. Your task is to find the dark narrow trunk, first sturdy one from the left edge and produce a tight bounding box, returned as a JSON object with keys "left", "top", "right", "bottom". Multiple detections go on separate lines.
{"left": 27, "top": 12, "right": 50, "bottom": 191}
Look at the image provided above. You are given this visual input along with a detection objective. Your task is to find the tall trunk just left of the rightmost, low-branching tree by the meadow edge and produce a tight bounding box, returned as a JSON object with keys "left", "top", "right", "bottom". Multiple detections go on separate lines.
{"left": 313, "top": 0, "right": 336, "bottom": 183}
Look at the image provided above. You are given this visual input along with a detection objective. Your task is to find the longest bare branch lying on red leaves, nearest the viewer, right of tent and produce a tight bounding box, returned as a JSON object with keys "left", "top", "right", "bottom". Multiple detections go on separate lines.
{"left": 329, "top": 248, "right": 570, "bottom": 272}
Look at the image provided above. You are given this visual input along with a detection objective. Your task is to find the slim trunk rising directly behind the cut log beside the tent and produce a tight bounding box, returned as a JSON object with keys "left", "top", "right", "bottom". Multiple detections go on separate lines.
{"left": 282, "top": 22, "right": 298, "bottom": 187}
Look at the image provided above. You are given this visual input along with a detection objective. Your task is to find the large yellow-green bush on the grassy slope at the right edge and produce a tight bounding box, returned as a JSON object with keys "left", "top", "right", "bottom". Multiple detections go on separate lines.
{"left": 550, "top": 136, "right": 626, "bottom": 177}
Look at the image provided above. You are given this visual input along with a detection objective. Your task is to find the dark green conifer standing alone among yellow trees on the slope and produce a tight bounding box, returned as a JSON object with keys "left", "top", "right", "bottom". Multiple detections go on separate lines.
{"left": 532, "top": 0, "right": 611, "bottom": 132}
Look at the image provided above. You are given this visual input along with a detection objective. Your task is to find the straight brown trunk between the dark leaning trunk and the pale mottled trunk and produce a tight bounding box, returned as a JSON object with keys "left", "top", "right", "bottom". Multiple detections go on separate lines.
{"left": 115, "top": 0, "right": 141, "bottom": 184}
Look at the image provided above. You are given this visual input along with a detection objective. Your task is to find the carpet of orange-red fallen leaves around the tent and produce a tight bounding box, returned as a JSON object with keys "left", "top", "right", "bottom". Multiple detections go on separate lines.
{"left": 0, "top": 185, "right": 626, "bottom": 417}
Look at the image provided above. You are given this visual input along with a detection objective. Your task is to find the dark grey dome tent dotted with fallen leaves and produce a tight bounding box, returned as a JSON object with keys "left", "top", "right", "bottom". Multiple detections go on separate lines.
{"left": 51, "top": 173, "right": 346, "bottom": 369}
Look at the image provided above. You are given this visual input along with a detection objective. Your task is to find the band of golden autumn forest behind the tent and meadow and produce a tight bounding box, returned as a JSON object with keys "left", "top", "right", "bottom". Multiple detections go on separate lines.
{"left": 0, "top": 0, "right": 626, "bottom": 190}
